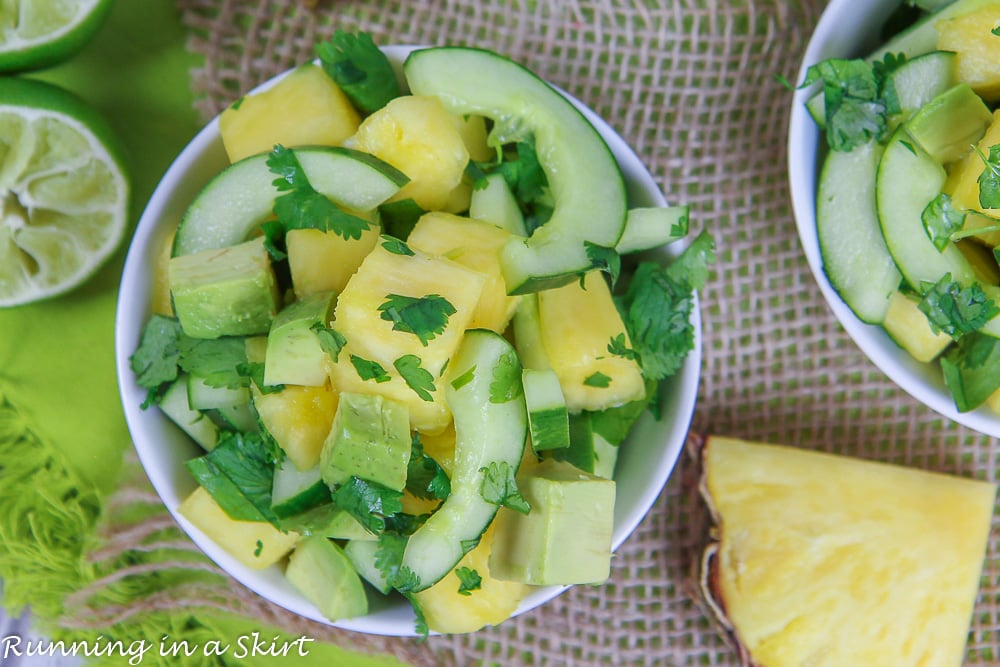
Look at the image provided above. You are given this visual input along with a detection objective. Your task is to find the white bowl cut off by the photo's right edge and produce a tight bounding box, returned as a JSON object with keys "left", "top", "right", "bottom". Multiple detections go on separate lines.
{"left": 788, "top": 0, "right": 1000, "bottom": 437}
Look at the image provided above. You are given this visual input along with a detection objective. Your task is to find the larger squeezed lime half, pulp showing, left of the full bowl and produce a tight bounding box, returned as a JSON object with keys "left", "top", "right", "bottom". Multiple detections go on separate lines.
{"left": 0, "top": 77, "right": 129, "bottom": 306}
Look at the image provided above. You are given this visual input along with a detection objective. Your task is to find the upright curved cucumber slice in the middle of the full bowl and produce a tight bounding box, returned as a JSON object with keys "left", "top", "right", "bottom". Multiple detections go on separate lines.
{"left": 402, "top": 329, "right": 528, "bottom": 590}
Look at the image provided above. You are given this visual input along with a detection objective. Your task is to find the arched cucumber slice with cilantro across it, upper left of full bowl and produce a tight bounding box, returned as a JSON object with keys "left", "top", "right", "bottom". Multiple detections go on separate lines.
{"left": 173, "top": 146, "right": 409, "bottom": 257}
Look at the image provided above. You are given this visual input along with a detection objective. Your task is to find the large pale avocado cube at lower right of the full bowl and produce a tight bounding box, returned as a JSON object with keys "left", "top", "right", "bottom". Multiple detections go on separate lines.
{"left": 490, "top": 460, "right": 615, "bottom": 586}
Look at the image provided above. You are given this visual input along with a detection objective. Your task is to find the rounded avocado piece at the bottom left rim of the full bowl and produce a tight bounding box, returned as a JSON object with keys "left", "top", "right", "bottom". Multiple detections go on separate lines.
{"left": 285, "top": 535, "right": 368, "bottom": 621}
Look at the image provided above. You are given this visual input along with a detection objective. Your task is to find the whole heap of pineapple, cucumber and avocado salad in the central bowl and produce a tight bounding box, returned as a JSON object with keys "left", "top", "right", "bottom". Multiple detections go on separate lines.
{"left": 131, "top": 32, "right": 714, "bottom": 633}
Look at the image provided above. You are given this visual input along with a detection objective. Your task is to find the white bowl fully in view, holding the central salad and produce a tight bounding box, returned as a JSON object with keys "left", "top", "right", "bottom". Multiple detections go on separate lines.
{"left": 115, "top": 47, "right": 701, "bottom": 636}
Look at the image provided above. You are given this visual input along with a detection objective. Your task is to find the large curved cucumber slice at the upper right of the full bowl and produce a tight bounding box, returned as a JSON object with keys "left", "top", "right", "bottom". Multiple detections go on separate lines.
{"left": 403, "top": 47, "right": 627, "bottom": 294}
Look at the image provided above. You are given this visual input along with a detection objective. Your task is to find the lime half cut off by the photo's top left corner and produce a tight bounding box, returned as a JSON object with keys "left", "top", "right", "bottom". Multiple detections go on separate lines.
{"left": 0, "top": 0, "right": 114, "bottom": 72}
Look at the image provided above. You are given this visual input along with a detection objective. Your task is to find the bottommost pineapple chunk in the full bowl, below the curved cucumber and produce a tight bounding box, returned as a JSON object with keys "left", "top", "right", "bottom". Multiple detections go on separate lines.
{"left": 414, "top": 527, "right": 528, "bottom": 633}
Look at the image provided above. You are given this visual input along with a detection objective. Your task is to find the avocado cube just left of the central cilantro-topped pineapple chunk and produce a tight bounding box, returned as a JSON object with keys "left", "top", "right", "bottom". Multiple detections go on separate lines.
{"left": 264, "top": 292, "right": 337, "bottom": 387}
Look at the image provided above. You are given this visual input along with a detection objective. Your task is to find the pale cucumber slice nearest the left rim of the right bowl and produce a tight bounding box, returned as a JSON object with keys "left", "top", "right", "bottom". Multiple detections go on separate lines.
{"left": 816, "top": 141, "right": 896, "bottom": 324}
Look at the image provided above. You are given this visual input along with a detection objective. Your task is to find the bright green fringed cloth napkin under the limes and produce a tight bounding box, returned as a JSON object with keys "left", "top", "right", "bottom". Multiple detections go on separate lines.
{"left": 0, "top": 0, "right": 400, "bottom": 667}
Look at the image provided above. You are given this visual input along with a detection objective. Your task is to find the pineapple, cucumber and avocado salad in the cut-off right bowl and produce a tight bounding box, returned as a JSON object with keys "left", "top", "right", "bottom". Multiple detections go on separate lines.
{"left": 803, "top": 0, "right": 1000, "bottom": 412}
